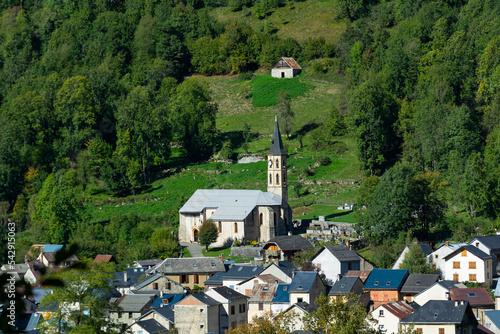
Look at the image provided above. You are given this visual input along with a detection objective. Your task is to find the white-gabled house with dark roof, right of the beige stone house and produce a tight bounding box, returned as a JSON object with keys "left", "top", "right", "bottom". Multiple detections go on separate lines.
{"left": 205, "top": 286, "right": 249, "bottom": 333}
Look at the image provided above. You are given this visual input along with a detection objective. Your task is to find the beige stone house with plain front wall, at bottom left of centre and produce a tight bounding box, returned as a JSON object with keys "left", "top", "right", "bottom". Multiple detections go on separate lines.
{"left": 174, "top": 293, "right": 222, "bottom": 334}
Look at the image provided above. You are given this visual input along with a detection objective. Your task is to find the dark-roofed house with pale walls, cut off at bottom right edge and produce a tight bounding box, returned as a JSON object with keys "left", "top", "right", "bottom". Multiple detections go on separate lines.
{"left": 401, "top": 300, "right": 479, "bottom": 334}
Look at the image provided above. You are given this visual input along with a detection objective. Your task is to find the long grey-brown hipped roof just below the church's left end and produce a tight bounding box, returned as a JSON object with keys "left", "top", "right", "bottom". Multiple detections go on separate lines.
{"left": 147, "top": 257, "right": 226, "bottom": 275}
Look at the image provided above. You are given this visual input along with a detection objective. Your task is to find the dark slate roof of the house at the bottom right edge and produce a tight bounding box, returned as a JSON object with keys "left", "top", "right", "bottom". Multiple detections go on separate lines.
{"left": 401, "top": 300, "right": 477, "bottom": 324}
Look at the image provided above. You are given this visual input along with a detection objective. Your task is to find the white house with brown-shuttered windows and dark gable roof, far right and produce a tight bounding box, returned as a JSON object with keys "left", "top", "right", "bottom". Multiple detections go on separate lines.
{"left": 444, "top": 246, "right": 493, "bottom": 287}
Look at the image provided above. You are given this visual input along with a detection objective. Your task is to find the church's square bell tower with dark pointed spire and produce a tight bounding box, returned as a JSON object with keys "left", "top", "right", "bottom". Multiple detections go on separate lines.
{"left": 267, "top": 116, "right": 288, "bottom": 202}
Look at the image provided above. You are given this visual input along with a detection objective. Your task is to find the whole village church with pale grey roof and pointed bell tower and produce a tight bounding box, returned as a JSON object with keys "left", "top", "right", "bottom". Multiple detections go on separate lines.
{"left": 179, "top": 118, "right": 292, "bottom": 247}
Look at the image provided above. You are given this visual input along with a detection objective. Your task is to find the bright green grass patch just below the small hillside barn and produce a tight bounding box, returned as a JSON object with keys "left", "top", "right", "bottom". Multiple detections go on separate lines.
{"left": 251, "top": 74, "right": 314, "bottom": 107}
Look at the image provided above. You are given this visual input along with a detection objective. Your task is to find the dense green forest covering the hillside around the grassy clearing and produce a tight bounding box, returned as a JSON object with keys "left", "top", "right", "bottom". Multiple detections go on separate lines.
{"left": 0, "top": 0, "right": 500, "bottom": 263}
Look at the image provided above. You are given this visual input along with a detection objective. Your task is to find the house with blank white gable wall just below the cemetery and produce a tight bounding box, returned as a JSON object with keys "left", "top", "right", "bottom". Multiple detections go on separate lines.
{"left": 311, "top": 245, "right": 361, "bottom": 284}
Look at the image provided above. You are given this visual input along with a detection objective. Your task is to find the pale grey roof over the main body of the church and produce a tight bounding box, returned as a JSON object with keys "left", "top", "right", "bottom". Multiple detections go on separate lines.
{"left": 179, "top": 189, "right": 282, "bottom": 220}
